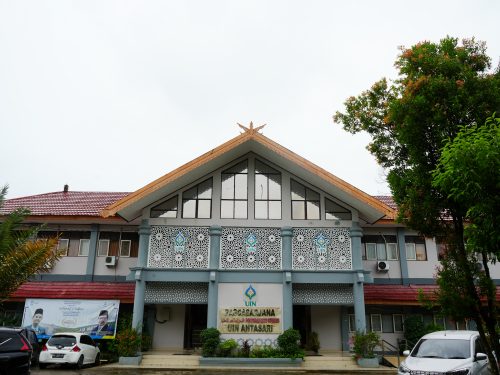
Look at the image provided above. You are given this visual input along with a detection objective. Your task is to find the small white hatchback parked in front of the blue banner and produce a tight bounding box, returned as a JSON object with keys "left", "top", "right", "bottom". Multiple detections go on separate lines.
{"left": 39, "top": 332, "right": 101, "bottom": 368}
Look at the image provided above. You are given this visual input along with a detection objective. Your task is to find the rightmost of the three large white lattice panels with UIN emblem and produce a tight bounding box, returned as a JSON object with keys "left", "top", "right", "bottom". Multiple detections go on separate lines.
{"left": 292, "top": 228, "right": 352, "bottom": 270}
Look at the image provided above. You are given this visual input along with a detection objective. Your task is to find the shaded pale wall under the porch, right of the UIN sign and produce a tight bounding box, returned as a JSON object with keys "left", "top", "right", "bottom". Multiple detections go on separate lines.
{"left": 311, "top": 305, "right": 342, "bottom": 353}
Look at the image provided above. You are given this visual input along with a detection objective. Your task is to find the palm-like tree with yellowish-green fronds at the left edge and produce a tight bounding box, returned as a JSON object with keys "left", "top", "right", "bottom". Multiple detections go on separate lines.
{"left": 0, "top": 187, "right": 59, "bottom": 302}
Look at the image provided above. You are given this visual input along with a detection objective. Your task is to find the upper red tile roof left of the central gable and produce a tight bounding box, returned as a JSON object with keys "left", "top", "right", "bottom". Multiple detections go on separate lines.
{"left": 0, "top": 191, "right": 130, "bottom": 216}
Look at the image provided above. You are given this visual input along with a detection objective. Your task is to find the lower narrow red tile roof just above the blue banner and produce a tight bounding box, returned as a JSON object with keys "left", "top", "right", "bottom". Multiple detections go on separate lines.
{"left": 10, "top": 281, "right": 135, "bottom": 303}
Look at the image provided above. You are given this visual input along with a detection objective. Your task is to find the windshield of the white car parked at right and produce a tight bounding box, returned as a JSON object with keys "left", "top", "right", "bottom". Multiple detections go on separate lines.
{"left": 411, "top": 339, "right": 470, "bottom": 359}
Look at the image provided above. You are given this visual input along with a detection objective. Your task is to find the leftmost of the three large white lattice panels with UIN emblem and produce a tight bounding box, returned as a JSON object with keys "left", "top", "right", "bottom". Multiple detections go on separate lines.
{"left": 148, "top": 225, "right": 210, "bottom": 269}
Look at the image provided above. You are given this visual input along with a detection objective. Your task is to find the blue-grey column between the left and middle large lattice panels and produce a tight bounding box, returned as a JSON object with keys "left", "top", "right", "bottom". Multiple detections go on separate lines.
{"left": 207, "top": 225, "right": 222, "bottom": 328}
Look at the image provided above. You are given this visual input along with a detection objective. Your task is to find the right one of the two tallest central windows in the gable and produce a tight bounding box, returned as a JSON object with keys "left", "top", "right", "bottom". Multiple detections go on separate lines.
{"left": 255, "top": 160, "right": 281, "bottom": 219}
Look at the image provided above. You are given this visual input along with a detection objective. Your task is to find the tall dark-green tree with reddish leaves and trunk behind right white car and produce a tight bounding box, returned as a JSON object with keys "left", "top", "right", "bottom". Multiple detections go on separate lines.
{"left": 334, "top": 37, "right": 500, "bottom": 374}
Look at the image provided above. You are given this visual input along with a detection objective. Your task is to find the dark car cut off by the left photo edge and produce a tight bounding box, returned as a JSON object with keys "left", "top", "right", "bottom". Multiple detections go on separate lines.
{"left": 0, "top": 327, "right": 33, "bottom": 375}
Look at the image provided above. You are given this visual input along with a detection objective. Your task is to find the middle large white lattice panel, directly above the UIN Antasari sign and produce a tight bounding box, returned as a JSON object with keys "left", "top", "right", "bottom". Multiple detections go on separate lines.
{"left": 220, "top": 227, "right": 281, "bottom": 270}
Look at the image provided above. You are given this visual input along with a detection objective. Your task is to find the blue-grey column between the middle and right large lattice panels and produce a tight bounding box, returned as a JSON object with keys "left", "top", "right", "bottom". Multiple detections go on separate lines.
{"left": 281, "top": 227, "right": 293, "bottom": 330}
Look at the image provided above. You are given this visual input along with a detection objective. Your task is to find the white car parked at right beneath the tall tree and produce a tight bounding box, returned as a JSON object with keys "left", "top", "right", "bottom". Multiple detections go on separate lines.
{"left": 398, "top": 331, "right": 490, "bottom": 375}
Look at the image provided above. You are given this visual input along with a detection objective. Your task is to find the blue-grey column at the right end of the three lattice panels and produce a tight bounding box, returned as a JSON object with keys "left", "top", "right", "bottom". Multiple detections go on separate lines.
{"left": 351, "top": 221, "right": 366, "bottom": 332}
